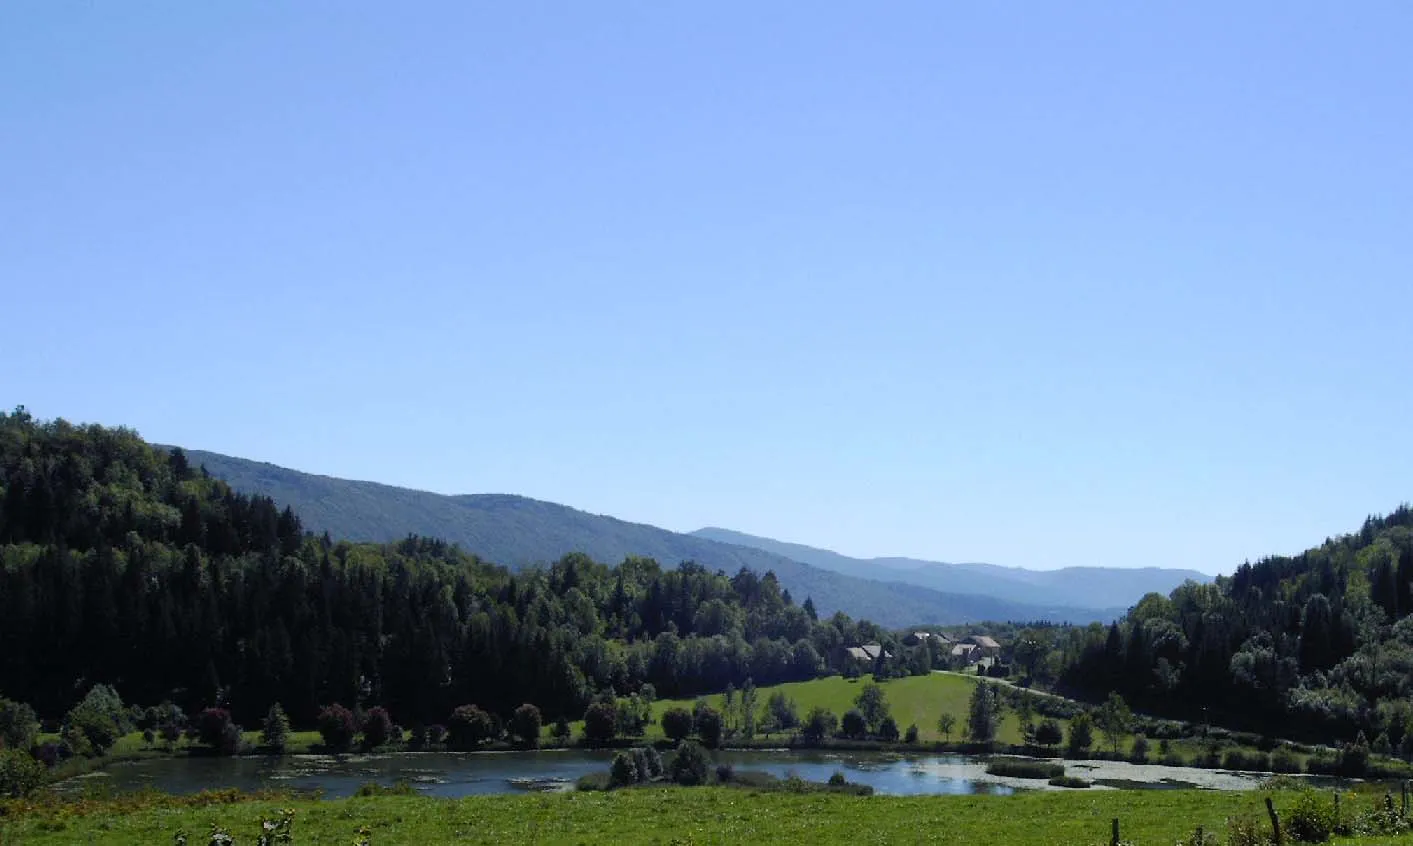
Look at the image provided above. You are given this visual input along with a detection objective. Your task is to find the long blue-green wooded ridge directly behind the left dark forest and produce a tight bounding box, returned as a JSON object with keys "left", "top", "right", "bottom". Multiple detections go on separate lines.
{"left": 187, "top": 449, "right": 1124, "bottom": 627}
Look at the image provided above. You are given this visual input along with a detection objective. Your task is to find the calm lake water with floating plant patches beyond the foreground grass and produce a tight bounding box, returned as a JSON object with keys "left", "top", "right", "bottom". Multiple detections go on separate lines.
{"left": 62, "top": 750, "right": 1283, "bottom": 798}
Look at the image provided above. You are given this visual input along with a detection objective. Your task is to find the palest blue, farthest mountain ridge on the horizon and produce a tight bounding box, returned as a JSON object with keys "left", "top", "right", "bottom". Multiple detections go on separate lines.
{"left": 691, "top": 527, "right": 1211, "bottom": 607}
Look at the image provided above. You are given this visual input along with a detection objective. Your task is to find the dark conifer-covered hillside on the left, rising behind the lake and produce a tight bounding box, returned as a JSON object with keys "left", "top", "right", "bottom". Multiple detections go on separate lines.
{"left": 0, "top": 410, "right": 887, "bottom": 725}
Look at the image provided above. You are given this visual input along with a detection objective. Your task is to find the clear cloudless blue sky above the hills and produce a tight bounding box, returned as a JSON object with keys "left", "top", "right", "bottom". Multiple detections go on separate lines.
{"left": 0, "top": 0, "right": 1413, "bottom": 572}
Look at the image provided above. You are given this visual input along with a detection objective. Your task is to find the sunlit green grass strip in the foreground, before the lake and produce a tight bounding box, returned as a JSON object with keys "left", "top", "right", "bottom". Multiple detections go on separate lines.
{"left": 0, "top": 788, "right": 1407, "bottom": 846}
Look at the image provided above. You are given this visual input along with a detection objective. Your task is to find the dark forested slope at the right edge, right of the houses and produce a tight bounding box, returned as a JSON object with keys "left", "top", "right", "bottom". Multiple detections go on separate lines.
{"left": 1063, "top": 506, "right": 1413, "bottom": 749}
